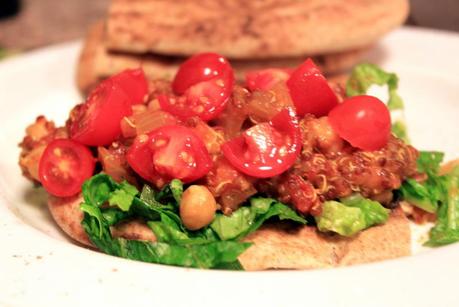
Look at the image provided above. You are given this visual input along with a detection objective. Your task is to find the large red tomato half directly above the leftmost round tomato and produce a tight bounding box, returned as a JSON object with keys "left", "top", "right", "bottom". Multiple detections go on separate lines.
{"left": 70, "top": 79, "right": 132, "bottom": 146}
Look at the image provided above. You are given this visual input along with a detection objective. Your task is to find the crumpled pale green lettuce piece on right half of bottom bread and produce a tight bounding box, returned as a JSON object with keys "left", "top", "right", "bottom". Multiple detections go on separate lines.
{"left": 315, "top": 194, "right": 390, "bottom": 236}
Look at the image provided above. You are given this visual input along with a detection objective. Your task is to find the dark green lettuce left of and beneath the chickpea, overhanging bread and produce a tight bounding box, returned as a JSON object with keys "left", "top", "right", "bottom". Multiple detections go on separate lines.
{"left": 81, "top": 174, "right": 250, "bottom": 269}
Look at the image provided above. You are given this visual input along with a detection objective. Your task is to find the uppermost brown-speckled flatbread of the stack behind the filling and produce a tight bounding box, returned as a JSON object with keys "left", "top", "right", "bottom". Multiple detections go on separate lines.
{"left": 107, "top": 0, "right": 409, "bottom": 58}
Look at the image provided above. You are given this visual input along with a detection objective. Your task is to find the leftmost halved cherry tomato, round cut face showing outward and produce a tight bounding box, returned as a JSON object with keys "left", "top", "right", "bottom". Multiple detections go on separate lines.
{"left": 38, "top": 139, "right": 95, "bottom": 197}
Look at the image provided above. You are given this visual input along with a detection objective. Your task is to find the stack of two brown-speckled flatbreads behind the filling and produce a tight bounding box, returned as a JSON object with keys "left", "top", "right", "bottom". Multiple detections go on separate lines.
{"left": 77, "top": 0, "right": 408, "bottom": 92}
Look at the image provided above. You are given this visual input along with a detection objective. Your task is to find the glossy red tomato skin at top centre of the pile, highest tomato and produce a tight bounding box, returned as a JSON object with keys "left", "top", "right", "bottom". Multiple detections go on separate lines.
{"left": 172, "top": 52, "right": 234, "bottom": 95}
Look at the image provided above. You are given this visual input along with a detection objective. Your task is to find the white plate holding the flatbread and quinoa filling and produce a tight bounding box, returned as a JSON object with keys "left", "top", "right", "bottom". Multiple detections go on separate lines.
{"left": 0, "top": 29, "right": 459, "bottom": 306}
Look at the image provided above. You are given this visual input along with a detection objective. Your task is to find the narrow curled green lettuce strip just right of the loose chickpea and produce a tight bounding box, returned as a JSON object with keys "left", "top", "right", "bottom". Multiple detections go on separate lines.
{"left": 210, "top": 197, "right": 306, "bottom": 240}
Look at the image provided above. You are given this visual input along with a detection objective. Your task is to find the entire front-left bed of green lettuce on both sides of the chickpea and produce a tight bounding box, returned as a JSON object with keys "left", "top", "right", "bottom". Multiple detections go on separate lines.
{"left": 81, "top": 174, "right": 306, "bottom": 269}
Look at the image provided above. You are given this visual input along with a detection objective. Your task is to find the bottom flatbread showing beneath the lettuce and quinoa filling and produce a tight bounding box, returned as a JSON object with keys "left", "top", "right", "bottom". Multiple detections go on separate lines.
{"left": 48, "top": 196, "right": 411, "bottom": 271}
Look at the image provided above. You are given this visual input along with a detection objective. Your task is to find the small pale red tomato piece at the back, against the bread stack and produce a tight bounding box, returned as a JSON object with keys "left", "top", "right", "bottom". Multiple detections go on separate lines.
{"left": 245, "top": 68, "right": 292, "bottom": 92}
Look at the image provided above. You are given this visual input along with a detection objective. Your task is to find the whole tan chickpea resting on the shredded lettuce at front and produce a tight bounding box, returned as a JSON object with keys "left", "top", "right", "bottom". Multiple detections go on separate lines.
{"left": 180, "top": 185, "right": 217, "bottom": 230}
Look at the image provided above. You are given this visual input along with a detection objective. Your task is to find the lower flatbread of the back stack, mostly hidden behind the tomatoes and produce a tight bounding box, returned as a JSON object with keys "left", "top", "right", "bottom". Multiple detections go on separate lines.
{"left": 77, "top": 22, "right": 369, "bottom": 93}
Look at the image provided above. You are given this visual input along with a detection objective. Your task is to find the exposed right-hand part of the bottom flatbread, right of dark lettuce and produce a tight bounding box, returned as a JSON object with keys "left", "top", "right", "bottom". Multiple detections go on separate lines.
{"left": 239, "top": 209, "right": 411, "bottom": 271}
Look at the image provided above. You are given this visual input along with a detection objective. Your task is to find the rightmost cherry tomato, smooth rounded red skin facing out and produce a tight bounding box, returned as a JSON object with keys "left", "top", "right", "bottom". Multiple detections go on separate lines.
{"left": 328, "top": 95, "right": 391, "bottom": 150}
